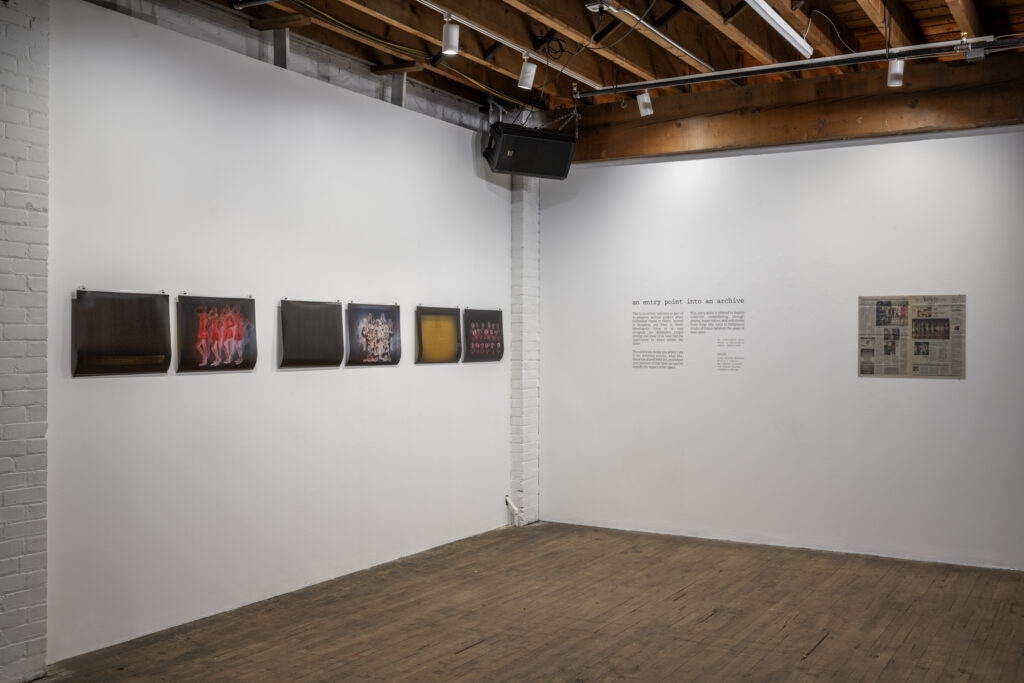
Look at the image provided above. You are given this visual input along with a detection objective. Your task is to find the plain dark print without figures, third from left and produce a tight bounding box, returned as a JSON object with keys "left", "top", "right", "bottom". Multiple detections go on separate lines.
{"left": 281, "top": 299, "right": 345, "bottom": 368}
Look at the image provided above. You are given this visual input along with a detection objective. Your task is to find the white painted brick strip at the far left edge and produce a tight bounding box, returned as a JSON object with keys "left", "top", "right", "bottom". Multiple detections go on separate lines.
{"left": 0, "top": 0, "right": 50, "bottom": 683}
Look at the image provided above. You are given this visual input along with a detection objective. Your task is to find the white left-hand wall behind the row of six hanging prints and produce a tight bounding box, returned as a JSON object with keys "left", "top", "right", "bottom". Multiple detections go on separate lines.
{"left": 47, "top": 2, "right": 510, "bottom": 661}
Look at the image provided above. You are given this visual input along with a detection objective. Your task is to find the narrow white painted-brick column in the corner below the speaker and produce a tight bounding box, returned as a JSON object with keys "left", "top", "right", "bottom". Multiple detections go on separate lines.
{"left": 508, "top": 176, "right": 541, "bottom": 523}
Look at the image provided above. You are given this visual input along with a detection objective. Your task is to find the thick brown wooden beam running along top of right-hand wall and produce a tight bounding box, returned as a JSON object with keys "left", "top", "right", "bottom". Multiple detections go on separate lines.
{"left": 574, "top": 52, "right": 1024, "bottom": 162}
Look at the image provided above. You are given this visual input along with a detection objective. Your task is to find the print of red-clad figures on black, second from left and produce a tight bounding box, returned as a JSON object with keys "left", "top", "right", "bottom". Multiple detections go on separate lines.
{"left": 178, "top": 296, "right": 256, "bottom": 373}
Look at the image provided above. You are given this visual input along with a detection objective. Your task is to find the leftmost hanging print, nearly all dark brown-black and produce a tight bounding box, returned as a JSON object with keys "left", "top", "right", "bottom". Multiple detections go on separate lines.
{"left": 71, "top": 290, "right": 171, "bottom": 377}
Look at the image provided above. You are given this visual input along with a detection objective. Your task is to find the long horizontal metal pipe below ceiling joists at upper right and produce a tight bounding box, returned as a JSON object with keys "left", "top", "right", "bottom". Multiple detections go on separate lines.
{"left": 578, "top": 36, "right": 1024, "bottom": 97}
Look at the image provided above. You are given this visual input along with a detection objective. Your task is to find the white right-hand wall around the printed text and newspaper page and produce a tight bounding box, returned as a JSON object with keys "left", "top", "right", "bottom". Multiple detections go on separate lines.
{"left": 541, "top": 129, "right": 1024, "bottom": 569}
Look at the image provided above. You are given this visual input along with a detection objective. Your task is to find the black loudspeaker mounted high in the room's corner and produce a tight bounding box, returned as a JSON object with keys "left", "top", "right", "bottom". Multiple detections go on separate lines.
{"left": 483, "top": 122, "right": 575, "bottom": 180}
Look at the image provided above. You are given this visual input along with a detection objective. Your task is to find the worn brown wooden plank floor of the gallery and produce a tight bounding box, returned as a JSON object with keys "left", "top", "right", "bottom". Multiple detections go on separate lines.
{"left": 46, "top": 523, "right": 1024, "bottom": 683}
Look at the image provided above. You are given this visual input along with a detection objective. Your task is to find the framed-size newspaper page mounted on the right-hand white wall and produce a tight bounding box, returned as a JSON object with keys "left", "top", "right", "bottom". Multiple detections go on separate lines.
{"left": 857, "top": 294, "right": 967, "bottom": 379}
